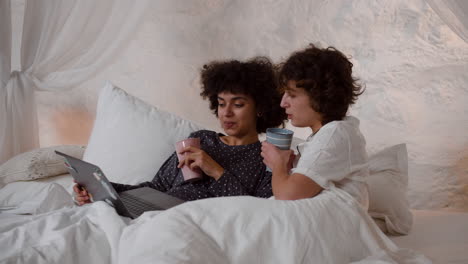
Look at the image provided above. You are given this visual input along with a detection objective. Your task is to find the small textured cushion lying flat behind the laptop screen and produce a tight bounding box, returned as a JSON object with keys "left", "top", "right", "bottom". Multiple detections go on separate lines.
{"left": 0, "top": 145, "right": 85, "bottom": 187}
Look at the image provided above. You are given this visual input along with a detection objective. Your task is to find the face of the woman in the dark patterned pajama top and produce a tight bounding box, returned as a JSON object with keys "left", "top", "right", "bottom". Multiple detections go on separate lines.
{"left": 218, "top": 92, "right": 257, "bottom": 138}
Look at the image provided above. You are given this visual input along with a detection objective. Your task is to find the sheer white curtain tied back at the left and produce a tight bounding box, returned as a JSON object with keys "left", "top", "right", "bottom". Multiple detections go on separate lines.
{"left": 0, "top": 0, "right": 148, "bottom": 164}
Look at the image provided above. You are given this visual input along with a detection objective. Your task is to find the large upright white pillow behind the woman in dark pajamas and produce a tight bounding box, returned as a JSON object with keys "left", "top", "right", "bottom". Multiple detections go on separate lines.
{"left": 83, "top": 82, "right": 202, "bottom": 184}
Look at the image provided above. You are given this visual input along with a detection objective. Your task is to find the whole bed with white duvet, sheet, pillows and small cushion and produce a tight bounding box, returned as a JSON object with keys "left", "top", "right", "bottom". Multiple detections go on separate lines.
{"left": 0, "top": 83, "right": 468, "bottom": 263}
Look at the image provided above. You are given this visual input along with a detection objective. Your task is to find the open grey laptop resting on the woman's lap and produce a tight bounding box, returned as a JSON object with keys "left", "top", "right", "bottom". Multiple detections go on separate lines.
{"left": 55, "top": 151, "right": 185, "bottom": 219}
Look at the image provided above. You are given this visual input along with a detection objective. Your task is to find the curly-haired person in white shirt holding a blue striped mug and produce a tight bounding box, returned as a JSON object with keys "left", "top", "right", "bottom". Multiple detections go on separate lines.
{"left": 261, "top": 45, "right": 369, "bottom": 207}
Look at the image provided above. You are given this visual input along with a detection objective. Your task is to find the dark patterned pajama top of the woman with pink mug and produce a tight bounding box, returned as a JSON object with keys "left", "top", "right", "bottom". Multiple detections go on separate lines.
{"left": 112, "top": 130, "right": 273, "bottom": 201}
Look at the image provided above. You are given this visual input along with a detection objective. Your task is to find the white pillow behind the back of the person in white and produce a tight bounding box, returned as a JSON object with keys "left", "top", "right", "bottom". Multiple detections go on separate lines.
{"left": 367, "top": 144, "right": 413, "bottom": 235}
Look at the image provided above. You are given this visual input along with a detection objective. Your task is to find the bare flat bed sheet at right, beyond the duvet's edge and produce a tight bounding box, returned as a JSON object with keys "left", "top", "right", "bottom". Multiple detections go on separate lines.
{"left": 390, "top": 210, "right": 468, "bottom": 264}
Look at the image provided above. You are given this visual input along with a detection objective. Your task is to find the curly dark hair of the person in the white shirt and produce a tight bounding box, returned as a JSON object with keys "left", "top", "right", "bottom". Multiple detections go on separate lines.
{"left": 279, "top": 44, "right": 364, "bottom": 125}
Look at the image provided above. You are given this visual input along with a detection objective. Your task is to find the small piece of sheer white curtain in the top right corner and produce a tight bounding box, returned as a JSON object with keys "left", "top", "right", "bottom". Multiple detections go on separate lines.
{"left": 426, "top": 0, "right": 468, "bottom": 42}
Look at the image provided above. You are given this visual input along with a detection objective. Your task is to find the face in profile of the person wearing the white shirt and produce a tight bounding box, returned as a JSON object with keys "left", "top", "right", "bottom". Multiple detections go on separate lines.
{"left": 280, "top": 81, "right": 322, "bottom": 132}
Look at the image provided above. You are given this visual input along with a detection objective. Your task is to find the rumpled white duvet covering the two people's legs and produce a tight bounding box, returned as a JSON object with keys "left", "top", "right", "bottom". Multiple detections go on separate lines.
{"left": 0, "top": 182, "right": 430, "bottom": 264}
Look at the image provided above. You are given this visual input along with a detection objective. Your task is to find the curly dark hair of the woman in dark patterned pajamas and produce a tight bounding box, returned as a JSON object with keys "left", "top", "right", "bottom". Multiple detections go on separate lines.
{"left": 200, "top": 57, "right": 287, "bottom": 133}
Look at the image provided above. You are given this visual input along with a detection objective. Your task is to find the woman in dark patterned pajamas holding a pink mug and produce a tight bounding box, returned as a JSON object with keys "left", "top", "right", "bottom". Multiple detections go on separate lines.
{"left": 74, "top": 57, "right": 286, "bottom": 205}
